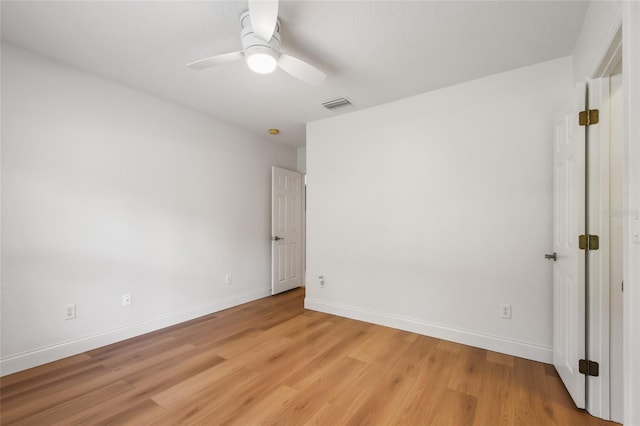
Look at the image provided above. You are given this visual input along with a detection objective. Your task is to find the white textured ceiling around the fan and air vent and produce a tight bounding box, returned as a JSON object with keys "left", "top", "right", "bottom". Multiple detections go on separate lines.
{"left": 1, "top": 0, "right": 588, "bottom": 146}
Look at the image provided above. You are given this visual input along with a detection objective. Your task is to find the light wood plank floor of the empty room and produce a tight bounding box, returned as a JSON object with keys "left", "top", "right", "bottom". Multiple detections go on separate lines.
{"left": 0, "top": 289, "right": 610, "bottom": 426}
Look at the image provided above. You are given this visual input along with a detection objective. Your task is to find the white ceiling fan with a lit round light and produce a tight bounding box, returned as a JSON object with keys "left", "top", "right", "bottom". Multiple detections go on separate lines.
{"left": 187, "top": 0, "right": 327, "bottom": 85}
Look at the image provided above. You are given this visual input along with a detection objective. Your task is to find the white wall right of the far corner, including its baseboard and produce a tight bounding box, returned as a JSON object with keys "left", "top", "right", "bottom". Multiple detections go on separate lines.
{"left": 305, "top": 58, "right": 573, "bottom": 362}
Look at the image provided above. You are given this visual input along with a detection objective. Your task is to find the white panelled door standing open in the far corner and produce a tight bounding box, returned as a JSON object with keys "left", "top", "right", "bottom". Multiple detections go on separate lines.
{"left": 271, "top": 167, "right": 303, "bottom": 294}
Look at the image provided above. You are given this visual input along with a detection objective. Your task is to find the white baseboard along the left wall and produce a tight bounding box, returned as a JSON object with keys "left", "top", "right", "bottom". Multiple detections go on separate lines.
{"left": 0, "top": 289, "right": 271, "bottom": 376}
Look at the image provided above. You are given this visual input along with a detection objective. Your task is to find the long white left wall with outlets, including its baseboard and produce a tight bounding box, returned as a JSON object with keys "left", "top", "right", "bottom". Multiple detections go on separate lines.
{"left": 1, "top": 45, "right": 296, "bottom": 374}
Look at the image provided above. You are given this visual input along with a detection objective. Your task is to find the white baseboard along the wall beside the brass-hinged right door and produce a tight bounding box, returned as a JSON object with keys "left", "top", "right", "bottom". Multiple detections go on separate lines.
{"left": 304, "top": 298, "right": 553, "bottom": 363}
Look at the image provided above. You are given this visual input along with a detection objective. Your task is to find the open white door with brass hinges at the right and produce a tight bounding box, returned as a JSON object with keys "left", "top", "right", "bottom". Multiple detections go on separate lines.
{"left": 553, "top": 84, "right": 586, "bottom": 408}
